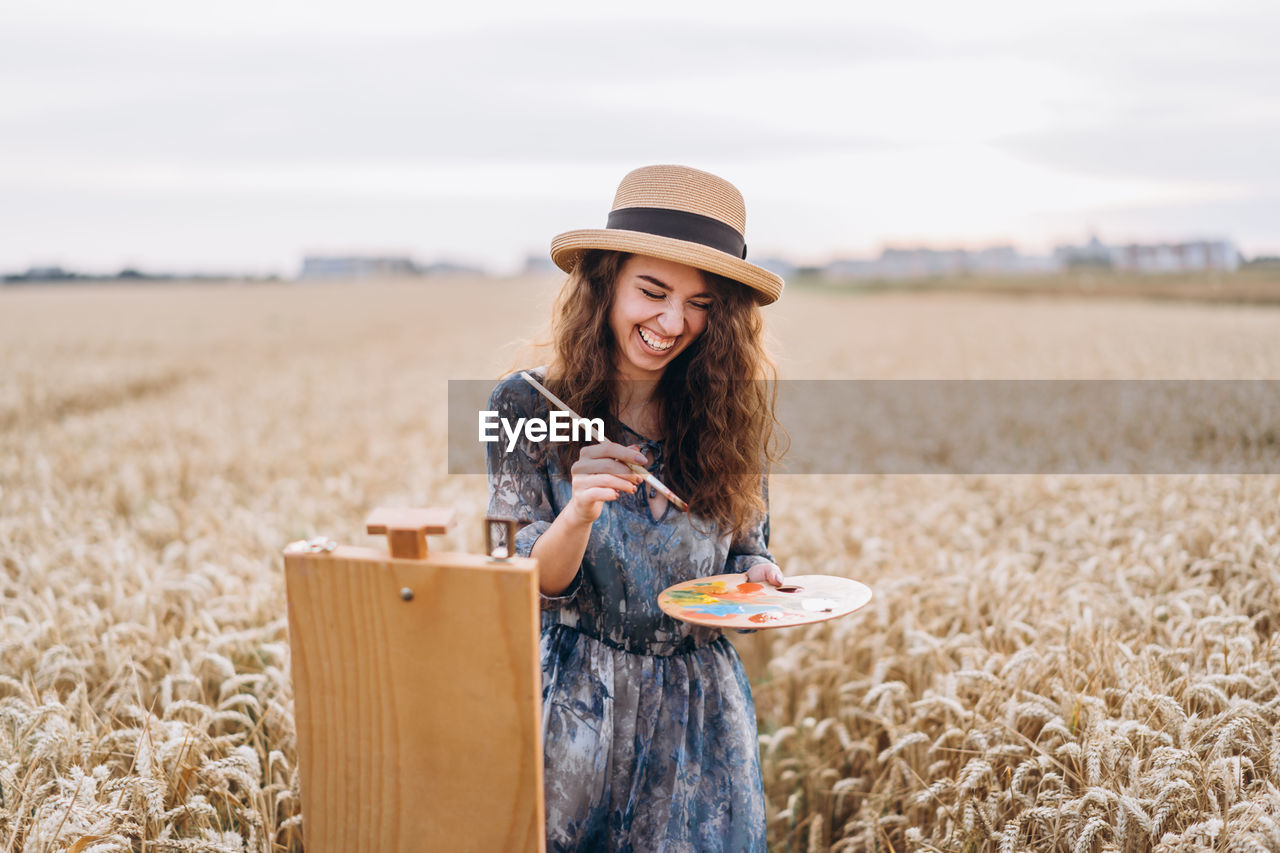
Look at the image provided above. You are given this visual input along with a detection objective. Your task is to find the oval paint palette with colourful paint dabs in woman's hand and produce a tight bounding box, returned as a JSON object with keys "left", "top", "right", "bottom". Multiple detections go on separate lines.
{"left": 658, "top": 574, "right": 872, "bottom": 628}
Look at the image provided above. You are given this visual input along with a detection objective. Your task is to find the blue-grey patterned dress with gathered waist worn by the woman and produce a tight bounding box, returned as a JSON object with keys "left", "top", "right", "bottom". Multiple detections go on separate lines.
{"left": 488, "top": 371, "right": 774, "bottom": 853}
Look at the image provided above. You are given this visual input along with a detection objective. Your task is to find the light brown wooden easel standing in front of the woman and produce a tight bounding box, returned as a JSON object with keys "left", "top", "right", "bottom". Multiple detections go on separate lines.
{"left": 284, "top": 510, "right": 545, "bottom": 853}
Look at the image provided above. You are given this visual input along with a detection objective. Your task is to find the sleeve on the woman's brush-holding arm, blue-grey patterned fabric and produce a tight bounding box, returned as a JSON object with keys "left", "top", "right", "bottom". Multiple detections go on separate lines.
{"left": 485, "top": 375, "right": 582, "bottom": 610}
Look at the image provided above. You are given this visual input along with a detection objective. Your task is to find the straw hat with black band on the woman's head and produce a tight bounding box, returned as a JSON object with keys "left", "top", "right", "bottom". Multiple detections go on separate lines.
{"left": 552, "top": 165, "right": 782, "bottom": 305}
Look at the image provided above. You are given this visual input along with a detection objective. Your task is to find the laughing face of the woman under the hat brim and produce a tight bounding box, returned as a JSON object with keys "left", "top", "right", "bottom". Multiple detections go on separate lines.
{"left": 609, "top": 255, "right": 714, "bottom": 379}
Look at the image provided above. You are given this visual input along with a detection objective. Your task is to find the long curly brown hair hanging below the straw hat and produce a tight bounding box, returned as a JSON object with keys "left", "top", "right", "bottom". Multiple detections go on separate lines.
{"left": 547, "top": 250, "right": 778, "bottom": 535}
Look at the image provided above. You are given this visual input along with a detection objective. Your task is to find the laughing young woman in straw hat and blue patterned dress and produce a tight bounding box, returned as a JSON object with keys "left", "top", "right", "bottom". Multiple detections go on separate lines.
{"left": 488, "top": 167, "right": 782, "bottom": 853}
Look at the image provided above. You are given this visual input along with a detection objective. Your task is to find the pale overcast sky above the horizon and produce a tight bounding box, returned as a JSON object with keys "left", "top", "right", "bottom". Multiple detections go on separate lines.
{"left": 0, "top": 0, "right": 1280, "bottom": 274}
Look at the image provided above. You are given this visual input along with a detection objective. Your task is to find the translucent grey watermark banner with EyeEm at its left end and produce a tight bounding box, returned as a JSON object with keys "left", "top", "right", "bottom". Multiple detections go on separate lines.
{"left": 449, "top": 379, "right": 1280, "bottom": 475}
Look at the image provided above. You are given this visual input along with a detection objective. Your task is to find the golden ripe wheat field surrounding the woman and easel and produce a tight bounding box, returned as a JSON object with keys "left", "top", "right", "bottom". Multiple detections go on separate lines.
{"left": 0, "top": 279, "right": 1280, "bottom": 853}
